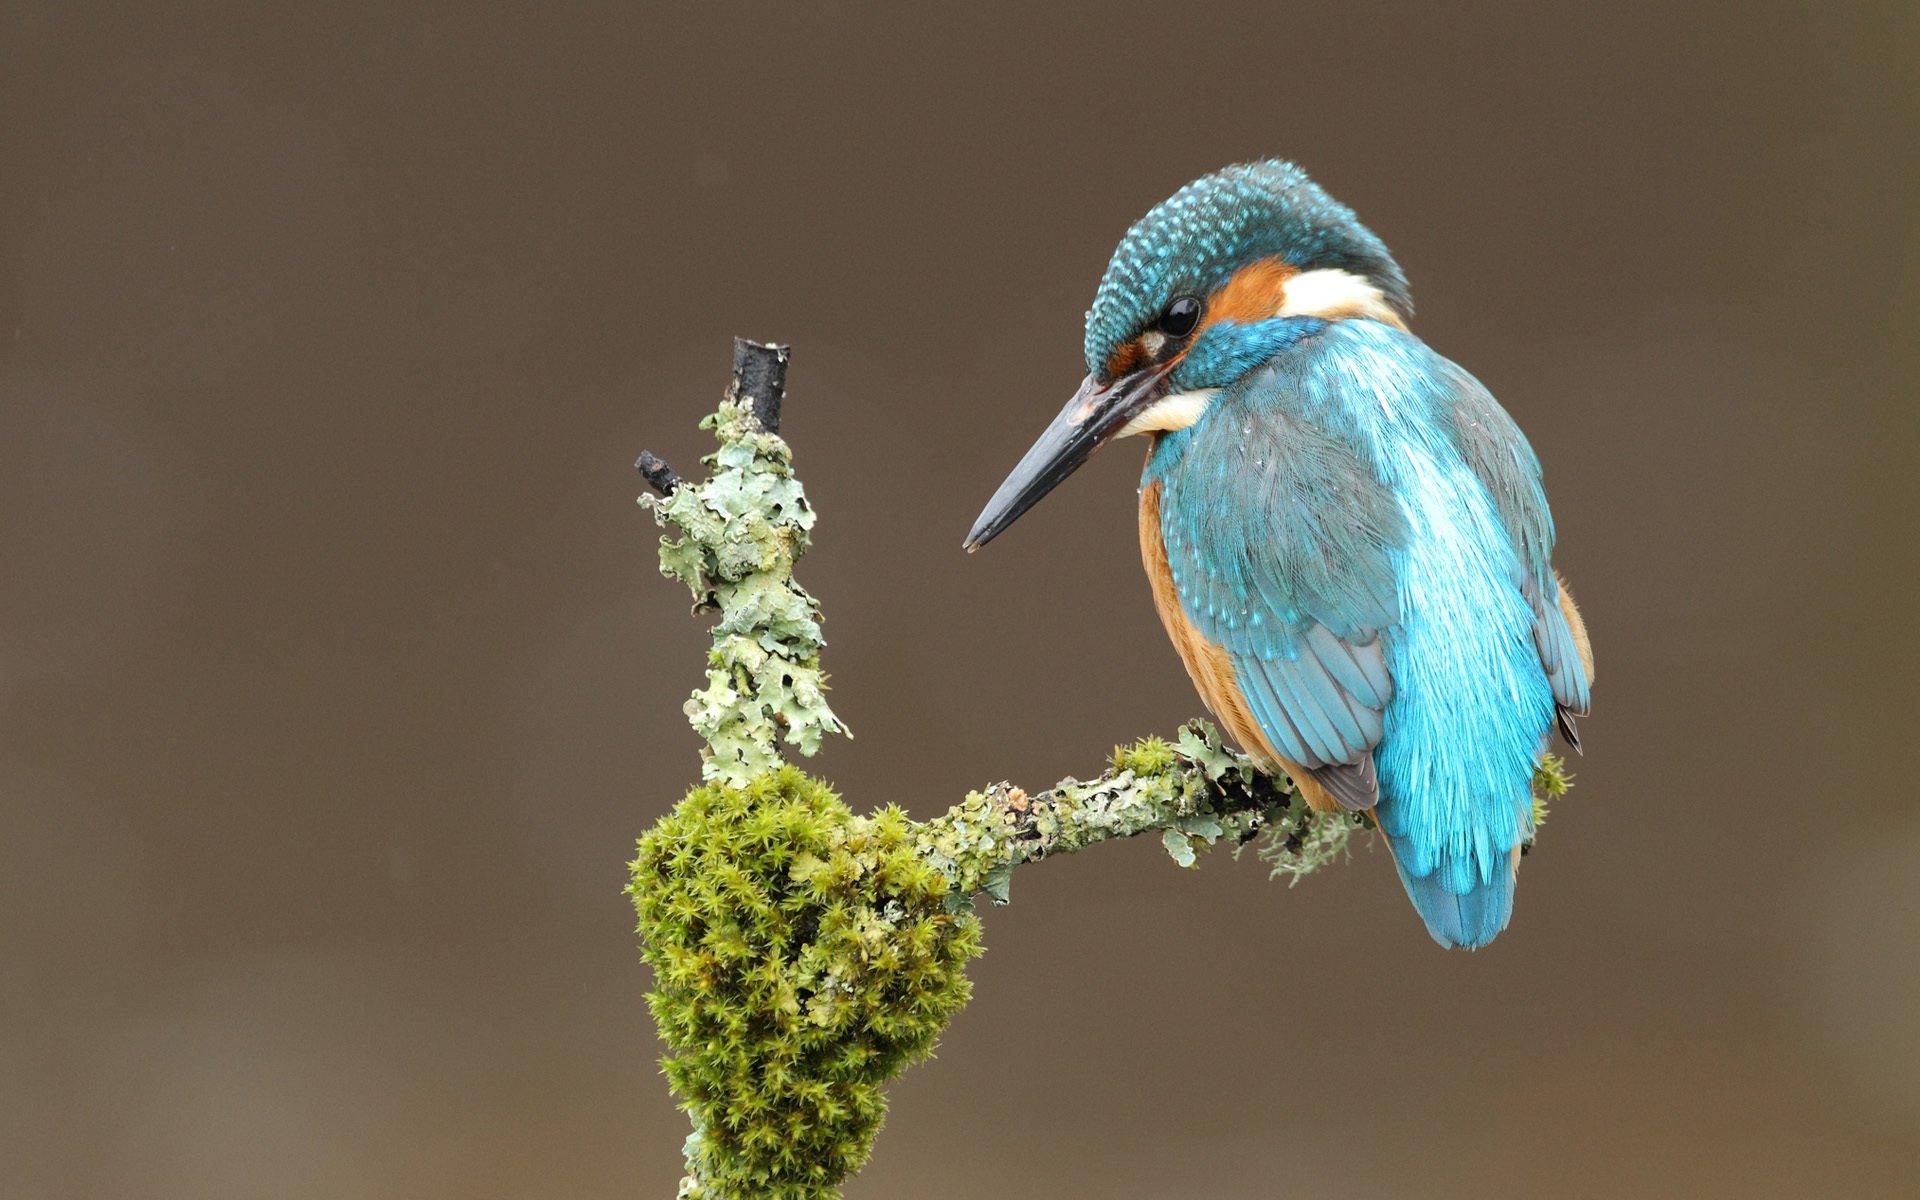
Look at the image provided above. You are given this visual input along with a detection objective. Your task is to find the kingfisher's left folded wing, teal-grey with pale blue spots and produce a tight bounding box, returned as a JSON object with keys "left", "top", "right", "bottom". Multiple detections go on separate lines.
{"left": 1148, "top": 355, "right": 1407, "bottom": 808}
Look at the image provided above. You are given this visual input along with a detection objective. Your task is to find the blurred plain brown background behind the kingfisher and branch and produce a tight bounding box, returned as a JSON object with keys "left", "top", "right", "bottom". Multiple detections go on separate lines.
{"left": 0, "top": 0, "right": 1920, "bottom": 1200}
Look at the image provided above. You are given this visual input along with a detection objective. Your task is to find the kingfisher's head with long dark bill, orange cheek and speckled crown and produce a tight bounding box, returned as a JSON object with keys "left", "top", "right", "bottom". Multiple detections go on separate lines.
{"left": 966, "top": 159, "right": 1413, "bottom": 549}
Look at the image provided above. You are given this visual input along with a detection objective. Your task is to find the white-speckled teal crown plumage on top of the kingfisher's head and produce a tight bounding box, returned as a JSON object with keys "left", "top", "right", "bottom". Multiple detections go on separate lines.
{"left": 1085, "top": 159, "right": 1413, "bottom": 374}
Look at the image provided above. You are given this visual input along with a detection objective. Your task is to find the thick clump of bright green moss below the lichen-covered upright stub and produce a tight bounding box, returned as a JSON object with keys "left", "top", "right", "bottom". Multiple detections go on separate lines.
{"left": 628, "top": 766, "right": 979, "bottom": 1200}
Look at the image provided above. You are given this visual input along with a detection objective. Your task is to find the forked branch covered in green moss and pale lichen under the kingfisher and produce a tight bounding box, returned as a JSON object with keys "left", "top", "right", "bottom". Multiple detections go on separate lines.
{"left": 628, "top": 340, "right": 1567, "bottom": 1200}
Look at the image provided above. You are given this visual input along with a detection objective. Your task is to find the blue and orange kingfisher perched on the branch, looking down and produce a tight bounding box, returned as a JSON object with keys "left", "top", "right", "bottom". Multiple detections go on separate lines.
{"left": 964, "top": 159, "right": 1594, "bottom": 948}
